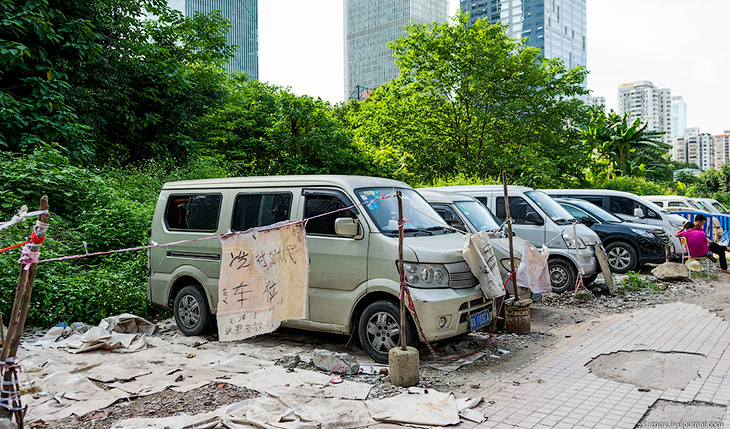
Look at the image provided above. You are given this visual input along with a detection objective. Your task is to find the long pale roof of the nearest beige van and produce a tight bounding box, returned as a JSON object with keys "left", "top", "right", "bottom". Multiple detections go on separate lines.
{"left": 162, "top": 174, "right": 410, "bottom": 190}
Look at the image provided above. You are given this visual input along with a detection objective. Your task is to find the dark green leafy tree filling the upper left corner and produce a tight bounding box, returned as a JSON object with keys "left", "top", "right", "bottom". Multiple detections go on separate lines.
{"left": 0, "top": 0, "right": 233, "bottom": 164}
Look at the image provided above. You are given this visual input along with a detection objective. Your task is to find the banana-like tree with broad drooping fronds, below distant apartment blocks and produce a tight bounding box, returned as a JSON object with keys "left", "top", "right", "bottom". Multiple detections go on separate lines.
{"left": 583, "top": 110, "right": 672, "bottom": 176}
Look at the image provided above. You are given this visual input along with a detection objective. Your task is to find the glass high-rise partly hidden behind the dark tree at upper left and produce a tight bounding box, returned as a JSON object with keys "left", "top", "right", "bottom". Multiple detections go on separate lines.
{"left": 168, "top": 0, "right": 259, "bottom": 79}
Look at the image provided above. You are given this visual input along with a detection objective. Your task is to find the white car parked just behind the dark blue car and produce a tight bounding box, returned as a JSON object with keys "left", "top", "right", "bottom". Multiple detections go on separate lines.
{"left": 544, "top": 189, "right": 686, "bottom": 255}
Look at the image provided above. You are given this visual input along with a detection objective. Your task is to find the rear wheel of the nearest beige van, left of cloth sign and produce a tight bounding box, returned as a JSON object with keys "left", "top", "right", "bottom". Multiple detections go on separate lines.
{"left": 173, "top": 285, "right": 215, "bottom": 336}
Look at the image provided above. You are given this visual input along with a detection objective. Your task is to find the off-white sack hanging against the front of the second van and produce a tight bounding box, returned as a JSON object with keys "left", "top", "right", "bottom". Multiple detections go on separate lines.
{"left": 462, "top": 231, "right": 504, "bottom": 299}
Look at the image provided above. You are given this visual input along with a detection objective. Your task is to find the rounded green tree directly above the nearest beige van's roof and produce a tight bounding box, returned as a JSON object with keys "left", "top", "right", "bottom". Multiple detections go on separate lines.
{"left": 201, "top": 75, "right": 369, "bottom": 175}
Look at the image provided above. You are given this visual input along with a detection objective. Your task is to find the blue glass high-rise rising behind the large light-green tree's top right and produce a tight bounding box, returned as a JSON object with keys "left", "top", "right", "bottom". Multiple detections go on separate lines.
{"left": 460, "top": 0, "right": 587, "bottom": 67}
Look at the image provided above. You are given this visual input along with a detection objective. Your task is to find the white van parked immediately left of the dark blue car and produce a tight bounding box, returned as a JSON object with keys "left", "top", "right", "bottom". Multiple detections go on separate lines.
{"left": 420, "top": 185, "right": 599, "bottom": 292}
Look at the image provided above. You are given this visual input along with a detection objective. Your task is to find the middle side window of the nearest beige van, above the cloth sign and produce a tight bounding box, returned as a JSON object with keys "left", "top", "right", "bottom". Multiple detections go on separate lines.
{"left": 231, "top": 193, "right": 292, "bottom": 231}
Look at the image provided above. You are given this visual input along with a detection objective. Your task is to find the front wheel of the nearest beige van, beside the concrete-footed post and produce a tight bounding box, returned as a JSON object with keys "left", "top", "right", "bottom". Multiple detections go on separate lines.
{"left": 357, "top": 300, "right": 418, "bottom": 363}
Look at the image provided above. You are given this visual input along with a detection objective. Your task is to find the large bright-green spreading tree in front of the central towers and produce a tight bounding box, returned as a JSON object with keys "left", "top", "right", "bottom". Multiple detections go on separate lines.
{"left": 350, "top": 13, "right": 587, "bottom": 185}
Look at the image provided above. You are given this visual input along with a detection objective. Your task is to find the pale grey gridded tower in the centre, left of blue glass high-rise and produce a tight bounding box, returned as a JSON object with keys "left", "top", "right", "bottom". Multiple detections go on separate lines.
{"left": 344, "top": 0, "right": 448, "bottom": 100}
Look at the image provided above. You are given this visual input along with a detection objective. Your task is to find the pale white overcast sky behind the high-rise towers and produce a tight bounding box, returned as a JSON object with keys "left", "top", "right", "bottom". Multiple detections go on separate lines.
{"left": 259, "top": 0, "right": 730, "bottom": 134}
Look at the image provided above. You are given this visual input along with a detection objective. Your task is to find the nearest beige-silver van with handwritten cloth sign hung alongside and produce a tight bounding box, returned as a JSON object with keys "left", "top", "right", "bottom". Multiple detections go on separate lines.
{"left": 148, "top": 175, "right": 496, "bottom": 362}
